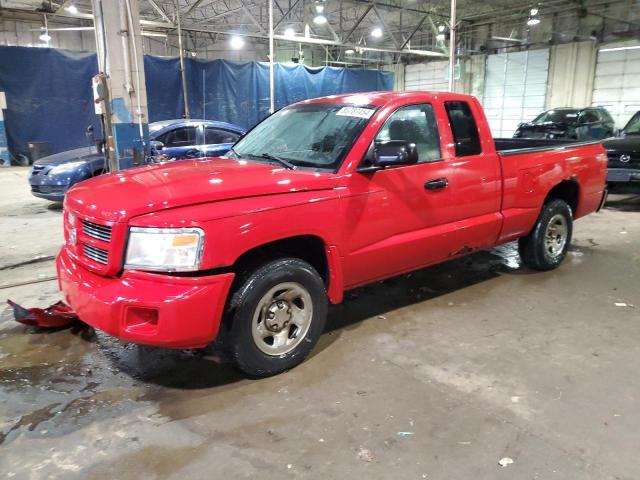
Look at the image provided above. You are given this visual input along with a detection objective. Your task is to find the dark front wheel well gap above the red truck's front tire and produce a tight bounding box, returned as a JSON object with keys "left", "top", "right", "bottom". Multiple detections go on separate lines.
{"left": 232, "top": 235, "right": 329, "bottom": 285}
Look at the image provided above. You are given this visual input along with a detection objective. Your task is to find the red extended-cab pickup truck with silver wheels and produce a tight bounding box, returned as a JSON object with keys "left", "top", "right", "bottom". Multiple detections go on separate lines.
{"left": 57, "top": 92, "right": 607, "bottom": 376}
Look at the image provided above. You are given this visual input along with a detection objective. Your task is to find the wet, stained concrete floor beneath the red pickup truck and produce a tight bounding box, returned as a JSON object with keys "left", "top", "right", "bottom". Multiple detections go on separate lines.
{"left": 0, "top": 169, "right": 640, "bottom": 480}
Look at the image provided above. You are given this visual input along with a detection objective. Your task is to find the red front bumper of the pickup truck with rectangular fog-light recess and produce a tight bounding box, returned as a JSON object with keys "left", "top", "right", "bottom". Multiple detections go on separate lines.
{"left": 56, "top": 248, "right": 234, "bottom": 348}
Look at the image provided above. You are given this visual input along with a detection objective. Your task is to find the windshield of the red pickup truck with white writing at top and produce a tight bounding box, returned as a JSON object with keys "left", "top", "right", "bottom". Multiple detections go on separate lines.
{"left": 227, "top": 103, "right": 375, "bottom": 170}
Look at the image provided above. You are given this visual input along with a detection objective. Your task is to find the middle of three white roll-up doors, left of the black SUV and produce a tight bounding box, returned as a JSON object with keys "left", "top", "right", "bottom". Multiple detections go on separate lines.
{"left": 482, "top": 48, "right": 549, "bottom": 137}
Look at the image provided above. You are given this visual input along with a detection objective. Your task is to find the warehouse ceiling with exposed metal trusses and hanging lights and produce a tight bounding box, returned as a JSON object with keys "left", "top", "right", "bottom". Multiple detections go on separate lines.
{"left": 0, "top": 0, "right": 640, "bottom": 61}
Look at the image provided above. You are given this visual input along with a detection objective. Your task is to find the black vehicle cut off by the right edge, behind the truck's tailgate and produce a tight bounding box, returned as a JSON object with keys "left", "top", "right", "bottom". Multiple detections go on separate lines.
{"left": 602, "top": 112, "right": 640, "bottom": 187}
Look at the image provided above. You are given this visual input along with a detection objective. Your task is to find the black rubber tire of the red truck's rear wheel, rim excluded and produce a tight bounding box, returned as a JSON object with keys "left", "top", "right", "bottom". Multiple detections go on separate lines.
{"left": 518, "top": 199, "right": 573, "bottom": 271}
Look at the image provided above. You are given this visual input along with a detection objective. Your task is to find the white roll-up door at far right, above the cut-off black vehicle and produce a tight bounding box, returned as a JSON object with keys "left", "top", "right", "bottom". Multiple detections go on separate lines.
{"left": 591, "top": 41, "right": 640, "bottom": 128}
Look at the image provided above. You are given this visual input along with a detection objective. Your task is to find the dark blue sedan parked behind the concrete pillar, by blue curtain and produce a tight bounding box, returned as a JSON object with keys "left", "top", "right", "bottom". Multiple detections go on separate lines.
{"left": 29, "top": 120, "right": 245, "bottom": 202}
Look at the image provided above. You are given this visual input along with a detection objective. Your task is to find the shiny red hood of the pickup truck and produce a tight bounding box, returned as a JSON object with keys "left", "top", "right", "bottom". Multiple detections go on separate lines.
{"left": 65, "top": 158, "right": 337, "bottom": 222}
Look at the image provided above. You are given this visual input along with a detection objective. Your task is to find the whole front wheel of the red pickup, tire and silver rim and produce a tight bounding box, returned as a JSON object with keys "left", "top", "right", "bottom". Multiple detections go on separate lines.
{"left": 222, "top": 258, "right": 327, "bottom": 377}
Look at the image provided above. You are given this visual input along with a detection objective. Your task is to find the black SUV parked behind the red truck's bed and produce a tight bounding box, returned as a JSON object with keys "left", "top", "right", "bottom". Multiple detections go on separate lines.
{"left": 513, "top": 107, "right": 615, "bottom": 140}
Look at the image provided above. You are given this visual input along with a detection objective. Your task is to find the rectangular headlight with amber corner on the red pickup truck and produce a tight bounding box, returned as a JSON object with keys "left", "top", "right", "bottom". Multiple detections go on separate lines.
{"left": 124, "top": 227, "right": 204, "bottom": 272}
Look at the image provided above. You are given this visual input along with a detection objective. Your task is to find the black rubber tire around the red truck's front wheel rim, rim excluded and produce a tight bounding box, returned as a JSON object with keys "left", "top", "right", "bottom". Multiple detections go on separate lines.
{"left": 221, "top": 258, "right": 327, "bottom": 377}
